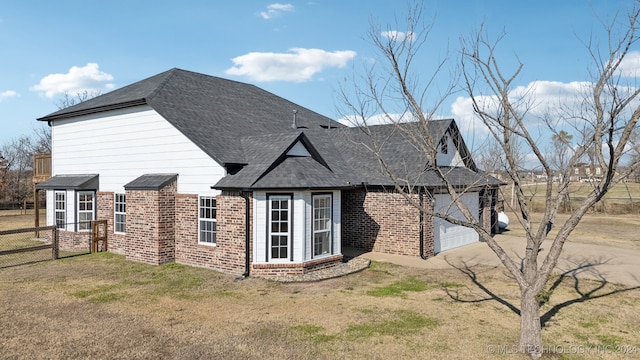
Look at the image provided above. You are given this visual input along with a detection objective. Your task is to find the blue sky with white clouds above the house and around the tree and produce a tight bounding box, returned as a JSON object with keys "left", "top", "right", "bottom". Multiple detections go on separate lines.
{"left": 0, "top": 0, "right": 640, "bottom": 150}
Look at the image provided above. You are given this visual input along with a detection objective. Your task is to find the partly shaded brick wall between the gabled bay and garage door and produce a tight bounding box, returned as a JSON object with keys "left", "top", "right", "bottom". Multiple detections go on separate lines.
{"left": 342, "top": 189, "right": 433, "bottom": 256}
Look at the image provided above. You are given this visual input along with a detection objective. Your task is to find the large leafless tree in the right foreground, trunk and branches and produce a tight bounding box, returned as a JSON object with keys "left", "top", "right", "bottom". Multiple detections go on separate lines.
{"left": 343, "top": 1, "right": 640, "bottom": 358}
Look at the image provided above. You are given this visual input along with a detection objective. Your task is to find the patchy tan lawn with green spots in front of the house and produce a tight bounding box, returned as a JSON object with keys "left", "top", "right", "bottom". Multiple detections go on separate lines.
{"left": 0, "top": 253, "right": 640, "bottom": 359}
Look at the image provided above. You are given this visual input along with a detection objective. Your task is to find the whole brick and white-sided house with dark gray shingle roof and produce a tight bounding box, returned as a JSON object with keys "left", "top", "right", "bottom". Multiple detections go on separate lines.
{"left": 38, "top": 69, "right": 500, "bottom": 277}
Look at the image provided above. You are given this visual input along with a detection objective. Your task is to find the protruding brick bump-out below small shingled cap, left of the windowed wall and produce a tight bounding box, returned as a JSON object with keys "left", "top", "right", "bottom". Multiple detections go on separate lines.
{"left": 124, "top": 181, "right": 176, "bottom": 264}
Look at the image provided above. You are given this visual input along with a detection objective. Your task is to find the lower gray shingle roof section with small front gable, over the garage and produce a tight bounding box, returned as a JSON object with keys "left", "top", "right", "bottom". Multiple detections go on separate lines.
{"left": 214, "top": 120, "right": 501, "bottom": 189}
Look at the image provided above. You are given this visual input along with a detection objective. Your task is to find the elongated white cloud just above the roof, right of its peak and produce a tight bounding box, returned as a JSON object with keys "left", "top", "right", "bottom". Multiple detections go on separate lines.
{"left": 225, "top": 48, "right": 356, "bottom": 82}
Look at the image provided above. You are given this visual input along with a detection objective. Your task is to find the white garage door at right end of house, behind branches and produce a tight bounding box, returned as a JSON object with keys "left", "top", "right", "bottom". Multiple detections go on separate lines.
{"left": 433, "top": 192, "right": 480, "bottom": 254}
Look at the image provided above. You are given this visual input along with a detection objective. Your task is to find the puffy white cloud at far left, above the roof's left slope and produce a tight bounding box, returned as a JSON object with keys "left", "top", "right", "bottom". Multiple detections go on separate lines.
{"left": 31, "top": 63, "right": 114, "bottom": 98}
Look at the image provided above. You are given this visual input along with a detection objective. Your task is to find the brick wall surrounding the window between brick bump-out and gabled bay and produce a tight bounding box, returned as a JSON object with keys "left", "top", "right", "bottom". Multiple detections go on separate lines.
{"left": 176, "top": 191, "right": 253, "bottom": 275}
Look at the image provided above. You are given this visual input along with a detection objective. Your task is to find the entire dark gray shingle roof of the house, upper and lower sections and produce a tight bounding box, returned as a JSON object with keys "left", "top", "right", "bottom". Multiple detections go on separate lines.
{"left": 38, "top": 69, "right": 500, "bottom": 189}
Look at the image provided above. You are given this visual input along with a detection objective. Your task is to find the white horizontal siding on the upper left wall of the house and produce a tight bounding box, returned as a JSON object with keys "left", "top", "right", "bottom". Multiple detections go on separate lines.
{"left": 51, "top": 106, "right": 225, "bottom": 195}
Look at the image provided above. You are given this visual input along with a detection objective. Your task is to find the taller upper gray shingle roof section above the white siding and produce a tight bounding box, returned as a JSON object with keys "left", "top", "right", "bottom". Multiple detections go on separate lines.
{"left": 38, "top": 69, "right": 343, "bottom": 165}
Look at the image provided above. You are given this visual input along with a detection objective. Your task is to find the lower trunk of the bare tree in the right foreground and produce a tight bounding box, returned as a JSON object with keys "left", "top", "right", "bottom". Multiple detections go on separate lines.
{"left": 518, "top": 289, "right": 542, "bottom": 359}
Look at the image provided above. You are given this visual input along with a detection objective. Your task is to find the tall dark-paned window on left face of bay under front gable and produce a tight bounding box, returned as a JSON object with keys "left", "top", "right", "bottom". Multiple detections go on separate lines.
{"left": 269, "top": 195, "right": 291, "bottom": 259}
